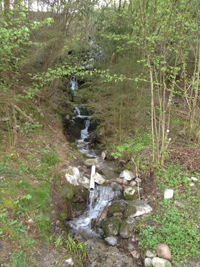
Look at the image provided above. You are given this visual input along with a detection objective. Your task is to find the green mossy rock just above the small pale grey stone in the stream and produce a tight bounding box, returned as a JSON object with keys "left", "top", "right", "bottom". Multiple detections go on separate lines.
{"left": 100, "top": 217, "right": 121, "bottom": 237}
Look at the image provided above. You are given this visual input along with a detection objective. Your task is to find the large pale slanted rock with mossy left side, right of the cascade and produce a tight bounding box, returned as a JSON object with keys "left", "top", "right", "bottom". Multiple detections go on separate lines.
{"left": 124, "top": 200, "right": 152, "bottom": 221}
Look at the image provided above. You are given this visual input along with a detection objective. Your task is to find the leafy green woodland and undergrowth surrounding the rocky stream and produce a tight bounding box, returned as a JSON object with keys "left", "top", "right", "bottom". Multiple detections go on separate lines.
{"left": 0, "top": 0, "right": 200, "bottom": 267}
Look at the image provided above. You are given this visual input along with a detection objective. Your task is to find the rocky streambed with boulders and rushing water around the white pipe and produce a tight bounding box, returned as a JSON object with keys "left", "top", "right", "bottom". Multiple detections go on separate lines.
{"left": 57, "top": 157, "right": 171, "bottom": 267}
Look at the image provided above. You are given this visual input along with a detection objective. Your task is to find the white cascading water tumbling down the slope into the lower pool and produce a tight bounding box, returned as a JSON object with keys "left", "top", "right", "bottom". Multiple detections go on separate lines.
{"left": 67, "top": 70, "right": 120, "bottom": 238}
